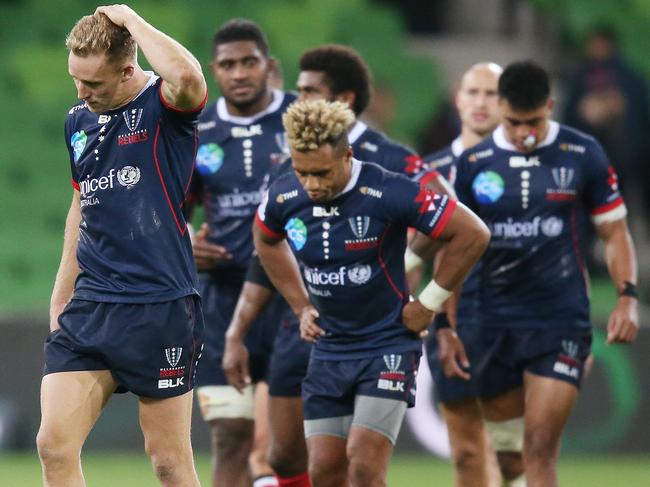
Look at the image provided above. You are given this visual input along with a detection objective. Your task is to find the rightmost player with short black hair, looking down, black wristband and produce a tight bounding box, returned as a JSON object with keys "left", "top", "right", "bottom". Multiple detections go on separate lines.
{"left": 446, "top": 62, "right": 638, "bottom": 487}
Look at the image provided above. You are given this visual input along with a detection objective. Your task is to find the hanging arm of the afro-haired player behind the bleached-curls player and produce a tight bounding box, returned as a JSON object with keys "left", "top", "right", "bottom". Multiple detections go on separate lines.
{"left": 222, "top": 262, "right": 275, "bottom": 391}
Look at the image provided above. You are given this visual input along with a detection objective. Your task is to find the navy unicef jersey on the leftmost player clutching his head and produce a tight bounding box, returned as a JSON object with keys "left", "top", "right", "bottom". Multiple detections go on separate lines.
{"left": 65, "top": 73, "right": 207, "bottom": 303}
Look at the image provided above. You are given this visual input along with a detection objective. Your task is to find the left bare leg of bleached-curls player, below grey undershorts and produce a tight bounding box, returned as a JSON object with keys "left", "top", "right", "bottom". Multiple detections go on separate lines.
{"left": 307, "top": 435, "right": 350, "bottom": 487}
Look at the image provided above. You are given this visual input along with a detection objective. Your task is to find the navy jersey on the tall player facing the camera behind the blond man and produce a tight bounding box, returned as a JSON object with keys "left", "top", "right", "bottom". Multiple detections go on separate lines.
{"left": 191, "top": 90, "right": 295, "bottom": 270}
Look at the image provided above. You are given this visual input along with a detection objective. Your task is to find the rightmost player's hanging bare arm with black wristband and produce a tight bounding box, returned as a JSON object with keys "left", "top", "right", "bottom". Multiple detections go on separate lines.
{"left": 596, "top": 218, "right": 639, "bottom": 343}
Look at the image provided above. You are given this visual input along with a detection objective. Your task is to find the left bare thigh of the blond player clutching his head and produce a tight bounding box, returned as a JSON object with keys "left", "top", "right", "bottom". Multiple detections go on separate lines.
{"left": 39, "top": 370, "right": 117, "bottom": 447}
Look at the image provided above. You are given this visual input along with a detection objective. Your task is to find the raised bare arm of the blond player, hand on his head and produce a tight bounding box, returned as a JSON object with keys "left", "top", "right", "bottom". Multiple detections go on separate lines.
{"left": 96, "top": 5, "right": 207, "bottom": 110}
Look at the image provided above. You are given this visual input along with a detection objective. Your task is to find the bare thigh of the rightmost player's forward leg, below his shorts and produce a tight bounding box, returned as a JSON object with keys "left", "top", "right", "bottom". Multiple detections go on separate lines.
{"left": 524, "top": 372, "right": 578, "bottom": 443}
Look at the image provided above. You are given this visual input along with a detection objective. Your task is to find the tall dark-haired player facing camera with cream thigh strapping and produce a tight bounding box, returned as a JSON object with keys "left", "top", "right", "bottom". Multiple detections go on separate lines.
{"left": 185, "top": 19, "right": 294, "bottom": 487}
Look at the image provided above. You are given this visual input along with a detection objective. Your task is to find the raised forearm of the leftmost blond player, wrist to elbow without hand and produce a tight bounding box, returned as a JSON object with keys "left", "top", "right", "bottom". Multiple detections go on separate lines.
{"left": 121, "top": 12, "right": 206, "bottom": 108}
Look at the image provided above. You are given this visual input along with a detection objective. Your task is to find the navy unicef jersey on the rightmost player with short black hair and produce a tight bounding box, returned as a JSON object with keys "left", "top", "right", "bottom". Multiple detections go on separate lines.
{"left": 456, "top": 122, "right": 627, "bottom": 328}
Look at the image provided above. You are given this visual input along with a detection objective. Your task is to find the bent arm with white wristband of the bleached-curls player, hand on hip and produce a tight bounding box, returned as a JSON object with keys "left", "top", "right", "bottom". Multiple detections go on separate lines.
{"left": 403, "top": 203, "right": 490, "bottom": 333}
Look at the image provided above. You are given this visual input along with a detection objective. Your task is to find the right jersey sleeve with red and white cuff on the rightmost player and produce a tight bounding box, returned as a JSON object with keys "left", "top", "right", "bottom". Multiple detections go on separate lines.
{"left": 582, "top": 142, "right": 627, "bottom": 225}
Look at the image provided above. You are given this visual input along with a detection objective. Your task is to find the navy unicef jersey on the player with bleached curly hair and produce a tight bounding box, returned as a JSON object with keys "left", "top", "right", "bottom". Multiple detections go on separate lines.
{"left": 256, "top": 159, "right": 456, "bottom": 359}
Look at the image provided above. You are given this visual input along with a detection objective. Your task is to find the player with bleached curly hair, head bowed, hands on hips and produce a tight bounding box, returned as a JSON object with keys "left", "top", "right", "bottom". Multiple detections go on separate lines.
{"left": 254, "top": 100, "right": 488, "bottom": 487}
